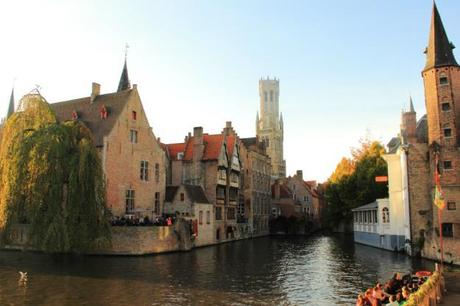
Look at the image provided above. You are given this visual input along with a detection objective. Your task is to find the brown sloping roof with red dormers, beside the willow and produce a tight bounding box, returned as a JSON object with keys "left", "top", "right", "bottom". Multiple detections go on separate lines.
{"left": 50, "top": 89, "right": 133, "bottom": 146}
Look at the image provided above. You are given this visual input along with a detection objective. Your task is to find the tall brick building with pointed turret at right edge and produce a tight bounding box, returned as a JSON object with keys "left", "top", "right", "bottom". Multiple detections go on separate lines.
{"left": 390, "top": 4, "right": 460, "bottom": 263}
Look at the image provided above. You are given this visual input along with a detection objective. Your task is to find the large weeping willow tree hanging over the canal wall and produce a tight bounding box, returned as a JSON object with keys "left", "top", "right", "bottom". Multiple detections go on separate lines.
{"left": 0, "top": 94, "right": 110, "bottom": 252}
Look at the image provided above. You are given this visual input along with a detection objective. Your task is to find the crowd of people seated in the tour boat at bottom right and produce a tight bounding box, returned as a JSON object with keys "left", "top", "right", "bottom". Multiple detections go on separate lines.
{"left": 356, "top": 273, "right": 428, "bottom": 306}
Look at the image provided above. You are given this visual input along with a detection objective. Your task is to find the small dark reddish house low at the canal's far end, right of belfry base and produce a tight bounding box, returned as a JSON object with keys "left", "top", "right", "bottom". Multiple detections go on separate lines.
{"left": 271, "top": 179, "right": 300, "bottom": 218}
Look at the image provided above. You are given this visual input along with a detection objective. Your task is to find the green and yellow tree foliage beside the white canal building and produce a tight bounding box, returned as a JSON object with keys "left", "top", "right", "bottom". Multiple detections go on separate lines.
{"left": 324, "top": 141, "right": 388, "bottom": 227}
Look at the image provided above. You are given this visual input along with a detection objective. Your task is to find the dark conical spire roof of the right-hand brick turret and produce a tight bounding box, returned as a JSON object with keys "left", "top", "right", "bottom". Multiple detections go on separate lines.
{"left": 424, "top": 2, "right": 458, "bottom": 70}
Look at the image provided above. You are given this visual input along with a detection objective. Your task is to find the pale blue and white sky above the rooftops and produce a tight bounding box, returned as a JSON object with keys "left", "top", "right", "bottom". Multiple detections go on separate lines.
{"left": 0, "top": 0, "right": 460, "bottom": 181}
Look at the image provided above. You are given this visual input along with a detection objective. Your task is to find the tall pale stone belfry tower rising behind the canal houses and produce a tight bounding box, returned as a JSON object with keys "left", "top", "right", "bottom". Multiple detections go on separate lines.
{"left": 256, "top": 78, "right": 286, "bottom": 178}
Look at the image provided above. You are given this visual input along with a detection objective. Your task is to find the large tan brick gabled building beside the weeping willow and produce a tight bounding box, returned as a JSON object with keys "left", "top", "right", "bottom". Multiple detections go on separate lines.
{"left": 50, "top": 61, "right": 166, "bottom": 218}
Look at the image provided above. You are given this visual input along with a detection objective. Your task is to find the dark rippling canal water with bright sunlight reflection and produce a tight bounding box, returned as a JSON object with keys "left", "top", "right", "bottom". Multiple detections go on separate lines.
{"left": 0, "top": 236, "right": 433, "bottom": 305}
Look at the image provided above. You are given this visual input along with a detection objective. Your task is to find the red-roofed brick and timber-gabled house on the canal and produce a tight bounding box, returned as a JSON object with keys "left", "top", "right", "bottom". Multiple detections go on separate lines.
{"left": 165, "top": 122, "right": 249, "bottom": 242}
